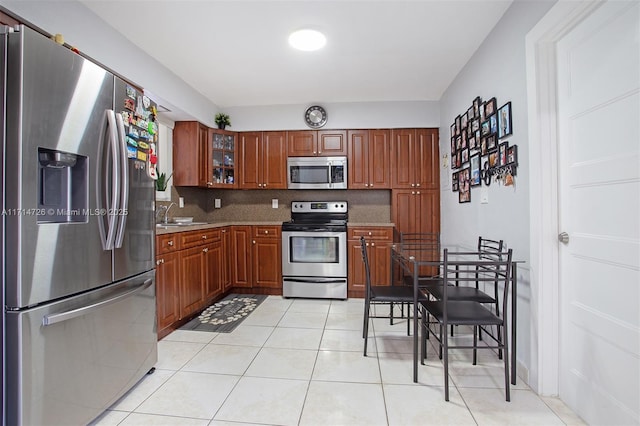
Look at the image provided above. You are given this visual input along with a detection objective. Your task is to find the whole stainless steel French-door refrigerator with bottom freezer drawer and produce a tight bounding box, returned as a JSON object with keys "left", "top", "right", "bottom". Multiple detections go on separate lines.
{"left": 0, "top": 27, "right": 157, "bottom": 425}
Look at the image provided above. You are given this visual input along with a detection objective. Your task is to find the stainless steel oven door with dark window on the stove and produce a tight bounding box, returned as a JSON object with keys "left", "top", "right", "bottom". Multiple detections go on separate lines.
{"left": 282, "top": 231, "right": 347, "bottom": 278}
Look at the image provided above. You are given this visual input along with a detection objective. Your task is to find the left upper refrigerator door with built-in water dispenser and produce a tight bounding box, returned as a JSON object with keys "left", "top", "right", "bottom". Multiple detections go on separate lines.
{"left": 5, "top": 28, "right": 114, "bottom": 307}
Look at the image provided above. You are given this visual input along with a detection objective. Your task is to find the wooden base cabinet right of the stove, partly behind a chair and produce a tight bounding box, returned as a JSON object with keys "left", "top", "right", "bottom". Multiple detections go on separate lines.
{"left": 347, "top": 226, "right": 393, "bottom": 297}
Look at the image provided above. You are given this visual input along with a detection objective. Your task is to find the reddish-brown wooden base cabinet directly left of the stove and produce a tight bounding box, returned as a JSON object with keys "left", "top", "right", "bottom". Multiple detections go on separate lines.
{"left": 251, "top": 226, "right": 282, "bottom": 289}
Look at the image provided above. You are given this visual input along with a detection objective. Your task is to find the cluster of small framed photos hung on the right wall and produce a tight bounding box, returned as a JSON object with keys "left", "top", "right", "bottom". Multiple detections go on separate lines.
{"left": 451, "top": 96, "right": 518, "bottom": 203}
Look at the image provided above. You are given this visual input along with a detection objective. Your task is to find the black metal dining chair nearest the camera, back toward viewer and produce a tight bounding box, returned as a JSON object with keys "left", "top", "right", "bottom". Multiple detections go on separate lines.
{"left": 420, "top": 249, "right": 512, "bottom": 401}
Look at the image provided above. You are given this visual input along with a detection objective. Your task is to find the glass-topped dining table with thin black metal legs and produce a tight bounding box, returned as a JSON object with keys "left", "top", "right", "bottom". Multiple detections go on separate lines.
{"left": 391, "top": 242, "right": 524, "bottom": 385}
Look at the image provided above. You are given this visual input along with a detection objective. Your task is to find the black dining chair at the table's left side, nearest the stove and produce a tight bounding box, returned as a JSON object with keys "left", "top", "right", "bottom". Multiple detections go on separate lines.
{"left": 360, "top": 237, "right": 420, "bottom": 356}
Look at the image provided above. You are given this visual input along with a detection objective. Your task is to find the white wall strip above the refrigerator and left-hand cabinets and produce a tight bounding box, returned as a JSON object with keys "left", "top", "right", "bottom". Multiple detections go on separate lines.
{"left": 0, "top": 0, "right": 218, "bottom": 126}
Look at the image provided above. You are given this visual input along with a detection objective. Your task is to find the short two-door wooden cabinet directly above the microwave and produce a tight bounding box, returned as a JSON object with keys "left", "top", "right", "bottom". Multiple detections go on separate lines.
{"left": 287, "top": 130, "right": 347, "bottom": 157}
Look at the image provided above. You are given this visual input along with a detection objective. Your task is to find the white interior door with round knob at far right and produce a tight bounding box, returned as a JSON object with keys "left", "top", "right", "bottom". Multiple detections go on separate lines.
{"left": 557, "top": 1, "right": 640, "bottom": 424}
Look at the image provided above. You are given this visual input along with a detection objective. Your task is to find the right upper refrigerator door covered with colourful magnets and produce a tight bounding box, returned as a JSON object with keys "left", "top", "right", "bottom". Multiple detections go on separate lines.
{"left": 114, "top": 78, "right": 155, "bottom": 281}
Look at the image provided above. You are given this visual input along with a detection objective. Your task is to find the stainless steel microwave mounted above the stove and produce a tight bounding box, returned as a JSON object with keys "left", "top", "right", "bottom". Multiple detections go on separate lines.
{"left": 287, "top": 157, "right": 347, "bottom": 189}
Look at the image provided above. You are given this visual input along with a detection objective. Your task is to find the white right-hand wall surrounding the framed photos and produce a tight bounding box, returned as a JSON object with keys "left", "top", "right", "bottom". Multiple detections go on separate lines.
{"left": 440, "top": 0, "right": 554, "bottom": 388}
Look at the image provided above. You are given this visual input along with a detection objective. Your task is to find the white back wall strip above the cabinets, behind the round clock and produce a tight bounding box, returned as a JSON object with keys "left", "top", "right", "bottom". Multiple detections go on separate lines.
{"left": 225, "top": 101, "right": 440, "bottom": 131}
